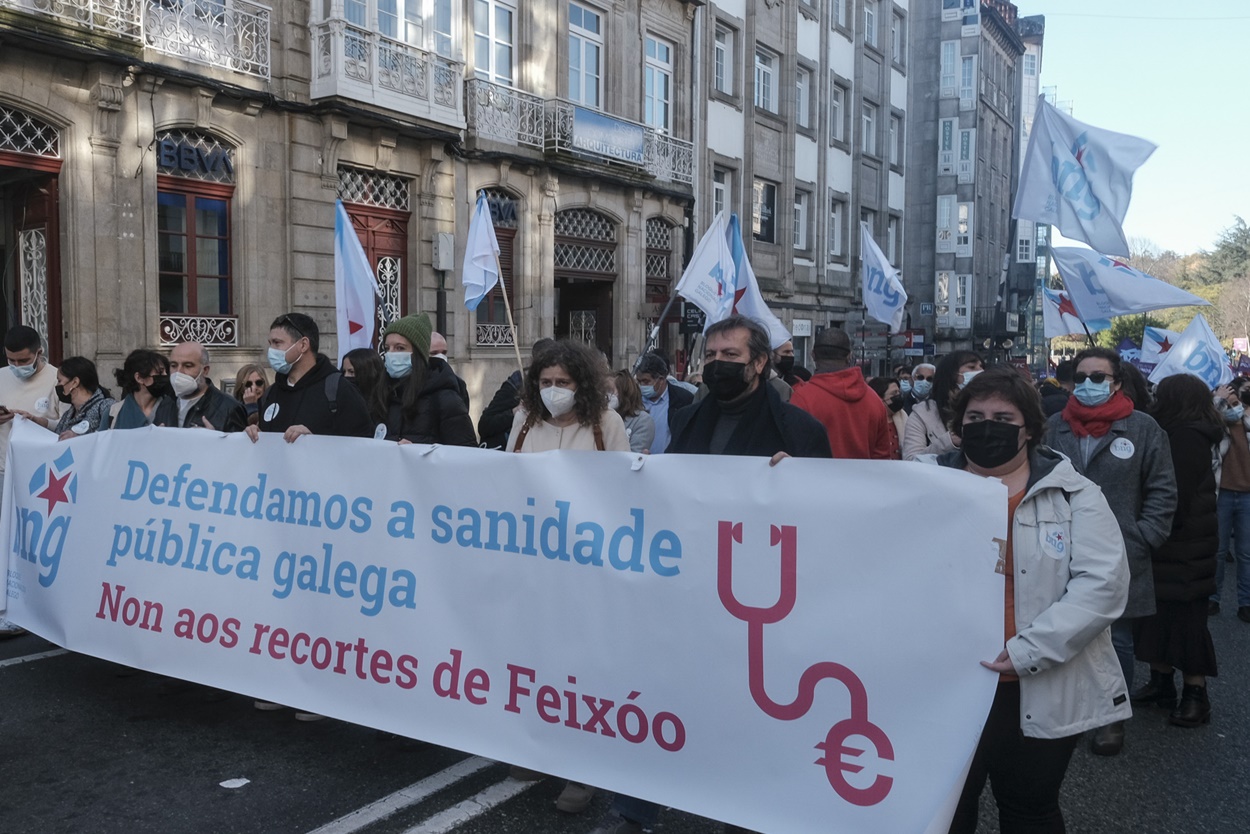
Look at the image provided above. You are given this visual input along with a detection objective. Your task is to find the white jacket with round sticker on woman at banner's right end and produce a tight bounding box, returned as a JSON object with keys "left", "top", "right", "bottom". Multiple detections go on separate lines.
{"left": 940, "top": 446, "right": 1133, "bottom": 739}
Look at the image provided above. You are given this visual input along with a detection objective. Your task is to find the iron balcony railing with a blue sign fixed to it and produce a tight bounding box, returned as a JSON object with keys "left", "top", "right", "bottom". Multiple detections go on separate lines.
{"left": 544, "top": 99, "right": 695, "bottom": 185}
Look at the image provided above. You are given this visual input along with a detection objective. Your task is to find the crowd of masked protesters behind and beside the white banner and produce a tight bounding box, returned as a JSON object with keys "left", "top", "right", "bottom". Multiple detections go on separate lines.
{"left": 0, "top": 313, "right": 1250, "bottom": 834}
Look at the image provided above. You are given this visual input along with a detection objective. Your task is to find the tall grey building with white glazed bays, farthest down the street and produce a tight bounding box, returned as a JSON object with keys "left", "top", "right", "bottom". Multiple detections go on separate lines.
{"left": 904, "top": 0, "right": 1035, "bottom": 359}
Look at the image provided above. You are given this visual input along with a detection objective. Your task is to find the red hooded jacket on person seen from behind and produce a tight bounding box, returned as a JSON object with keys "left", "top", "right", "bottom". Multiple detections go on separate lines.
{"left": 790, "top": 368, "right": 894, "bottom": 460}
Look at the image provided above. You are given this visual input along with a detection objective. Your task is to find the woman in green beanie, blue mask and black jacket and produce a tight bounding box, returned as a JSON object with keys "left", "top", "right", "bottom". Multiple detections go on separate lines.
{"left": 383, "top": 313, "right": 478, "bottom": 446}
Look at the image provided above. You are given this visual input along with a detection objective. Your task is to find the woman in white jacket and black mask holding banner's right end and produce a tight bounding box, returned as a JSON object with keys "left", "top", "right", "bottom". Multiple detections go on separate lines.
{"left": 938, "top": 368, "right": 1131, "bottom": 834}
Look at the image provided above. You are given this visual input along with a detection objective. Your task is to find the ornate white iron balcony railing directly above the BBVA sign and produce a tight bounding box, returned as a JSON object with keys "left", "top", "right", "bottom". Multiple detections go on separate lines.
{"left": 144, "top": 0, "right": 270, "bottom": 79}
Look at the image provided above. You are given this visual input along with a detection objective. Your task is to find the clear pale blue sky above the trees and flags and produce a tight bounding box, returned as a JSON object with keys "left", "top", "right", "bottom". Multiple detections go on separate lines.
{"left": 1015, "top": 0, "right": 1250, "bottom": 255}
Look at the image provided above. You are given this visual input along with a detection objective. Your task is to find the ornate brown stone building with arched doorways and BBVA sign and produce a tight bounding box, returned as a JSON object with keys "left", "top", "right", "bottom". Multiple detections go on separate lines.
{"left": 0, "top": 0, "right": 700, "bottom": 397}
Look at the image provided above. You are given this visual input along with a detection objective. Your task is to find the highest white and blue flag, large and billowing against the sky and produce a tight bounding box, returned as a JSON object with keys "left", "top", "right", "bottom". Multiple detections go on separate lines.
{"left": 1011, "top": 96, "right": 1155, "bottom": 258}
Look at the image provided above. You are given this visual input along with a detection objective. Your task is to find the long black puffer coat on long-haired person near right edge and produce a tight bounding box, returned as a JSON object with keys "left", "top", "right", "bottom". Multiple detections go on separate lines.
{"left": 1151, "top": 423, "right": 1223, "bottom": 603}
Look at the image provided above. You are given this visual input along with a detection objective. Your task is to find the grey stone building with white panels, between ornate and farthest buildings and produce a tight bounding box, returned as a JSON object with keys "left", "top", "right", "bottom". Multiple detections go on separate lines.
{"left": 698, "top": 0, "right": 910, "bottom": 372}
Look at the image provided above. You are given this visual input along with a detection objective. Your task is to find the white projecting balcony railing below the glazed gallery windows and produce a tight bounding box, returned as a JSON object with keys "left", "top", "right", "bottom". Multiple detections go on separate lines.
{"left": 311, "top": 19, "right": 465, "bottom": 129}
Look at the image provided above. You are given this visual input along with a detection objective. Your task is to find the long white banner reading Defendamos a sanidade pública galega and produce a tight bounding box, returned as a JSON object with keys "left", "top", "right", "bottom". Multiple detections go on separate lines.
{"left": 3, "top": 421, "right": 1006, "bottom": 834}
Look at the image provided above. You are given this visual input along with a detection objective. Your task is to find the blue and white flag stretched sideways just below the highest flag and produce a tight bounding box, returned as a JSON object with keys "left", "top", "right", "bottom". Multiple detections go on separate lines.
{"left": 1050, "top": 246, "right": 1210, "bottom": 321}
